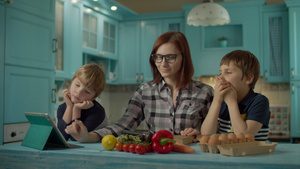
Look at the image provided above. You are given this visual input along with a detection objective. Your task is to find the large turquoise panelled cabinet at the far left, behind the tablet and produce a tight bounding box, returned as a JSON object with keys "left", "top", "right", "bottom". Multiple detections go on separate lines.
{"left": 0, "top": 0, "right": 56, "bottom": 143}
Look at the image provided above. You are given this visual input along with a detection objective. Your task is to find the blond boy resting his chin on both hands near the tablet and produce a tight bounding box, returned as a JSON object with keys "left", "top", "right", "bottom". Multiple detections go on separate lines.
{"left": 57, "top": 63, "right": 105, "bottom": 141}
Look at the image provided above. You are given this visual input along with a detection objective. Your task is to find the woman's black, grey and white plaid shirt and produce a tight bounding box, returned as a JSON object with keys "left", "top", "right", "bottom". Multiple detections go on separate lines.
{"left": 95, "top": 80, "right": 213, "bottom": 137}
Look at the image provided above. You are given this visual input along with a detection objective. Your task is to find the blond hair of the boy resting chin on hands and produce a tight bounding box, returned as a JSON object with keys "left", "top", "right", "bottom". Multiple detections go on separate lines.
{"left": 72, "top": 63, "right": 106, "bottom": 98}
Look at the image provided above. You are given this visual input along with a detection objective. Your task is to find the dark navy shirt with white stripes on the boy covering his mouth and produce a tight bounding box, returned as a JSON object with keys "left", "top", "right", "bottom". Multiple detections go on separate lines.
{"left": 218, "top": 90, "right": 271, "bottom": 141}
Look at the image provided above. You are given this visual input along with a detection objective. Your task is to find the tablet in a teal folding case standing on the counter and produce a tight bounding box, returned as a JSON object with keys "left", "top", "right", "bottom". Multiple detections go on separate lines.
{"left": 22, "top": 112, "right": 82, "bottom": 150}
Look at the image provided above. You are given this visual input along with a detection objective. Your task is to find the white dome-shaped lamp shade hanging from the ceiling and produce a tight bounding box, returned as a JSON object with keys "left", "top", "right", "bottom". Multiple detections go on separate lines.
{"left": 187, "top": 2, "right": 230, "bottom": 26}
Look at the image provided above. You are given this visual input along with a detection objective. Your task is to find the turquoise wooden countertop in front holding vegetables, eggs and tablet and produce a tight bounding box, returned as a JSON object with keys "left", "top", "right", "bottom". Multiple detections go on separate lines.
{"left": 0, "top": 142, "right": 300, "bottom": 169}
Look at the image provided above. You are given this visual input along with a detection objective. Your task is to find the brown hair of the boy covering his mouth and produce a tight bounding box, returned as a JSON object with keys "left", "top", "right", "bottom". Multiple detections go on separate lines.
{"left": 220, "top": 50, "right": 260, "bottom": 89}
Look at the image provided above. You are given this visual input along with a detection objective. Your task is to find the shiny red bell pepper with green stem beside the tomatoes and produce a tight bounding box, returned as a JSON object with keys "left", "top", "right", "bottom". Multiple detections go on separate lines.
{"left": 151, "top": 130, "right": 175, "bottom": 154}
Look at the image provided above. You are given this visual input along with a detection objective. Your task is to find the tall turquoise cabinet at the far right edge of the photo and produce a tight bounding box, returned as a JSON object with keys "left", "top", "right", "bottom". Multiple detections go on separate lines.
{"left": 285, "top": 0, "right": 300, "bottom": 141}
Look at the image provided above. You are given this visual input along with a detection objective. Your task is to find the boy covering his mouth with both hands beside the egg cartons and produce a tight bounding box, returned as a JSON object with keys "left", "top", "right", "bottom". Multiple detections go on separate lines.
{"left": 201, "top": 50, "right": 270, "bottom": 141}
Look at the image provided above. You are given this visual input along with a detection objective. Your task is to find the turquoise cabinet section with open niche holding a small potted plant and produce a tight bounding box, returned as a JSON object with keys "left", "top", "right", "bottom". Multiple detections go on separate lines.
{"left": 183, "top": 0, "right": 265, "bottom": 77}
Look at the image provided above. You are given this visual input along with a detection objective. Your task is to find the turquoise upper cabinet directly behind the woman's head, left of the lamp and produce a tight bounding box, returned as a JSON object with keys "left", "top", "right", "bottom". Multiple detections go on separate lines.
{"left": 118, "top": 17, "right": 184, "bottom": 84}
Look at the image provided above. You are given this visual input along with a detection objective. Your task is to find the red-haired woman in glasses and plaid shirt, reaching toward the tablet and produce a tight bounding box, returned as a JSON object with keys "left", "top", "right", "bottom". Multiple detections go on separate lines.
{"left": 66, "top": 32, "right": 213, "bottom": 142}
